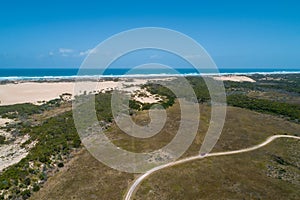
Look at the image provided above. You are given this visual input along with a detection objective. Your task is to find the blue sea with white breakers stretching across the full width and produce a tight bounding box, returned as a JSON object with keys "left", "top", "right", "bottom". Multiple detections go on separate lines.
{"left": 0, "top": 68, "right": 300, "bottom": 80}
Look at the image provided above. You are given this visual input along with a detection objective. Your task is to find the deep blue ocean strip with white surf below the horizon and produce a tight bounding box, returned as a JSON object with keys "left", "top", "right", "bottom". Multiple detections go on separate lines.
{"left": 0, "top": 68, "right": 300, "bottom": 81}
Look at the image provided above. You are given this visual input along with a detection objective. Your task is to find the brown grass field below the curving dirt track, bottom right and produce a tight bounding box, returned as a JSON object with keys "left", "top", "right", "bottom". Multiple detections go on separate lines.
{"left": 134, "top": 139, "right": 300, "bottom": 200}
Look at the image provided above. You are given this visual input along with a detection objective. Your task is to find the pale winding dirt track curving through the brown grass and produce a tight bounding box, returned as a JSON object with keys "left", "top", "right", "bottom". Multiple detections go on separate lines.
{"left": 124, "top": 135, "right": 300, "bottom": 200}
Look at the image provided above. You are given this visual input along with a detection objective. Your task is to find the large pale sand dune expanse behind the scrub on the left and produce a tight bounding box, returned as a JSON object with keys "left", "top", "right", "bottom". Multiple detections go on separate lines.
{"left": 0, "top": 78, "right": 171, "bottom": 105}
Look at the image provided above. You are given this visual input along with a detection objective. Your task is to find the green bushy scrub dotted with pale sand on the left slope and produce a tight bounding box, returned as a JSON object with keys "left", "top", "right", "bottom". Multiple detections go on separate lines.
{"left": 0, "top": 94, "right": 112, "bottom": 199}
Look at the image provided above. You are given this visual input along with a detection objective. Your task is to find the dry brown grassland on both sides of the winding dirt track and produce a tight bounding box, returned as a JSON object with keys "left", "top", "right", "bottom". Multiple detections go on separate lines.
{"left": 31, "top": 104, "right": 300, "bottom": 200}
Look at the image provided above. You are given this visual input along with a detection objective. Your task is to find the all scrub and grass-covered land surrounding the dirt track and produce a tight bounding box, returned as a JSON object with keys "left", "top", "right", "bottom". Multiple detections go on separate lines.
{"left": 0, "top": 75, "right": 300, "bottom": 199}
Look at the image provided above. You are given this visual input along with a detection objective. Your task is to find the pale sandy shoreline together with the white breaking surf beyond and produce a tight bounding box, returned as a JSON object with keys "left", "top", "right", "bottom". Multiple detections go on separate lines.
{"left": 0, "top": 71, "right": 300, "bottom": 106}
